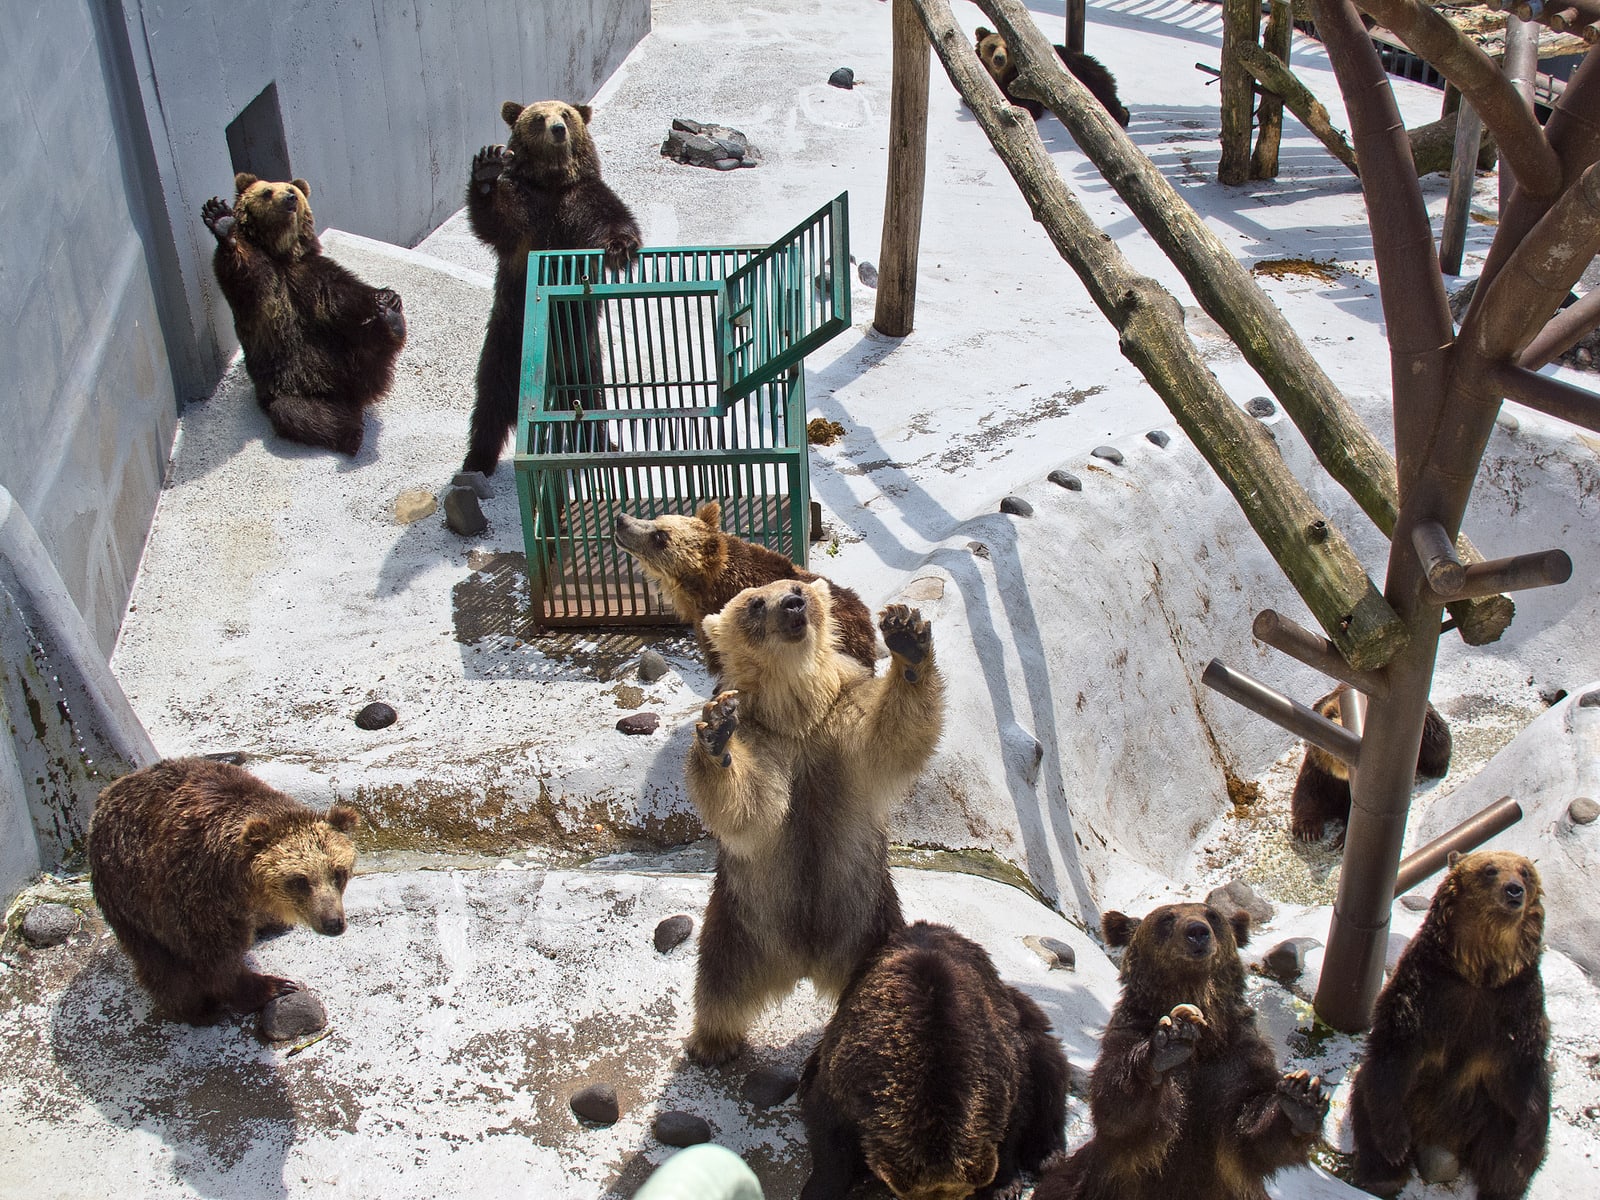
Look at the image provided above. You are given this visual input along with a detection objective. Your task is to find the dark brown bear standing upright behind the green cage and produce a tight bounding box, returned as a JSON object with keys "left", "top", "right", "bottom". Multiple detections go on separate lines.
{"left": 461, "top": 101, "right": 642, "bottom": 475}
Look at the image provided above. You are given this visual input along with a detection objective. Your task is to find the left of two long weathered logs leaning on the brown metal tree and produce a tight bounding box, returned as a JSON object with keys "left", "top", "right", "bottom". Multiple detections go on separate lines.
{"left": 914, "top": 0, "right": 1398, "bottom": 669}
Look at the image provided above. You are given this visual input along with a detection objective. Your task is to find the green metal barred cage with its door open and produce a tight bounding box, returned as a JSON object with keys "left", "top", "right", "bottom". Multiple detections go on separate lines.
{"left": 512, "top": 195, "right": 850, "bottom": 627}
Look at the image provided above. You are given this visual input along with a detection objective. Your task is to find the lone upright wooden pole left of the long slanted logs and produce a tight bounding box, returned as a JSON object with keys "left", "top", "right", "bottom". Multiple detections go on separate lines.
{"left": 872, "top": 0, "right": 928, "bottom": 338}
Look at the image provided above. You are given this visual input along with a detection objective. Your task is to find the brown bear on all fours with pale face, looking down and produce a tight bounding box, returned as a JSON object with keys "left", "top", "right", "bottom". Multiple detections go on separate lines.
{"left": 90, "top": 758, "right": 358, "bottom": 1024}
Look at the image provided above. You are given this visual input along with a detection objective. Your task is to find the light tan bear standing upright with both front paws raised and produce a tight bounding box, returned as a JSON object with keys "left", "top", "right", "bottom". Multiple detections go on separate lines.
{"left": 686, "top": 579, "right": 944, "bottom": 1064}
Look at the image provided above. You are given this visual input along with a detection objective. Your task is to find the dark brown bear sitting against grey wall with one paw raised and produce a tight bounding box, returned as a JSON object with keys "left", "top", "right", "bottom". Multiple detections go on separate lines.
{"left": 200, "top": 171, "right": 405, "bottom": 454}
